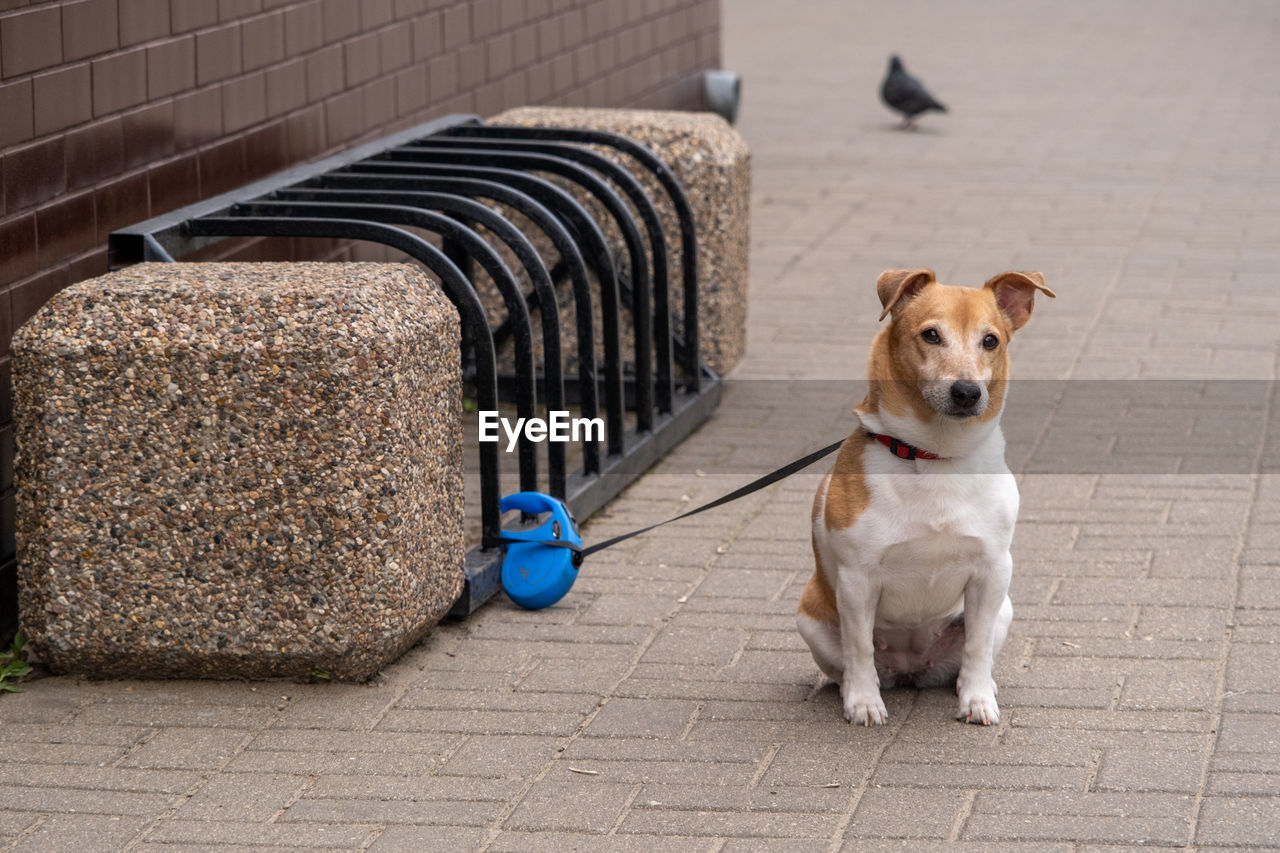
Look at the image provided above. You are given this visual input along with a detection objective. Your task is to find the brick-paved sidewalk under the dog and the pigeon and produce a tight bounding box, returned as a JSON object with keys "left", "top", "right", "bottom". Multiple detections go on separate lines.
{"left": 0, "top": 0, "right": 1280, "bottom": 853}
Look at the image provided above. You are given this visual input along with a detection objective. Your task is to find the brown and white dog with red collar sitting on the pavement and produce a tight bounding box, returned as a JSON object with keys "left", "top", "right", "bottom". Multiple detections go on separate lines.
{"left": 796, "top": 269, "right": 1053, "bottom": 725}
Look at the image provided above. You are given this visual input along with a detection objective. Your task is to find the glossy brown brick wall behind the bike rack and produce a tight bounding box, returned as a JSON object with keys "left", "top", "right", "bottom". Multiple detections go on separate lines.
{"left": 0, "top": 0, "right": 719, "bottom": 634}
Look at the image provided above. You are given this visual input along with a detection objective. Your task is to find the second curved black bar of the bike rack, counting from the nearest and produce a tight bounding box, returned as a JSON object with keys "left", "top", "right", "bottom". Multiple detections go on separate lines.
{"left": 232, "top": 201, "right": 538, "bottom": 492}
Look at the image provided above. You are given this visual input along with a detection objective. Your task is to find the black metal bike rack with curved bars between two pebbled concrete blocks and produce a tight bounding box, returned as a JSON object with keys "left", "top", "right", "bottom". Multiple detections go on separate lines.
{"left": 109, "top": 115, "right": 721, "bottom": 616}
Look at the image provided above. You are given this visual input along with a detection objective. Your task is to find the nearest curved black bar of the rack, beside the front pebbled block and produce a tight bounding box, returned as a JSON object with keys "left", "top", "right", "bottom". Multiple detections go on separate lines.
{"left": 183, "top": 216, "right": 502, "bottom": 548}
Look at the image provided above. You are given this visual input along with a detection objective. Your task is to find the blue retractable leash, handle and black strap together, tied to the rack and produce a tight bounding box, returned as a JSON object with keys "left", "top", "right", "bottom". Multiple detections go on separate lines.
{"left": 493, "top": 438, "right": 845, "bottom": 610}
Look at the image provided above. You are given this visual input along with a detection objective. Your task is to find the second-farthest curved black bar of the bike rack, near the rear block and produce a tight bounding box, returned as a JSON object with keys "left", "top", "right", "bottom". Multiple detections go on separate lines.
{"left": 410, "top": 137, "right": 672, "bottom": 412}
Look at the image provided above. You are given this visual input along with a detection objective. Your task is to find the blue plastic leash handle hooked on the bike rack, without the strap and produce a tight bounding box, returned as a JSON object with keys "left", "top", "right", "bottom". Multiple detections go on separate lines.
{"left": 499, "top": 492, "right": 582, "bottom": 610}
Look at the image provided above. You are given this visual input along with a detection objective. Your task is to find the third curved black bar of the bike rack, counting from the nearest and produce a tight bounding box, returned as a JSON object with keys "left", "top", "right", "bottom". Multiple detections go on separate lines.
{"left": 273, "top": 188, "right": 567, "bottom": 498}
